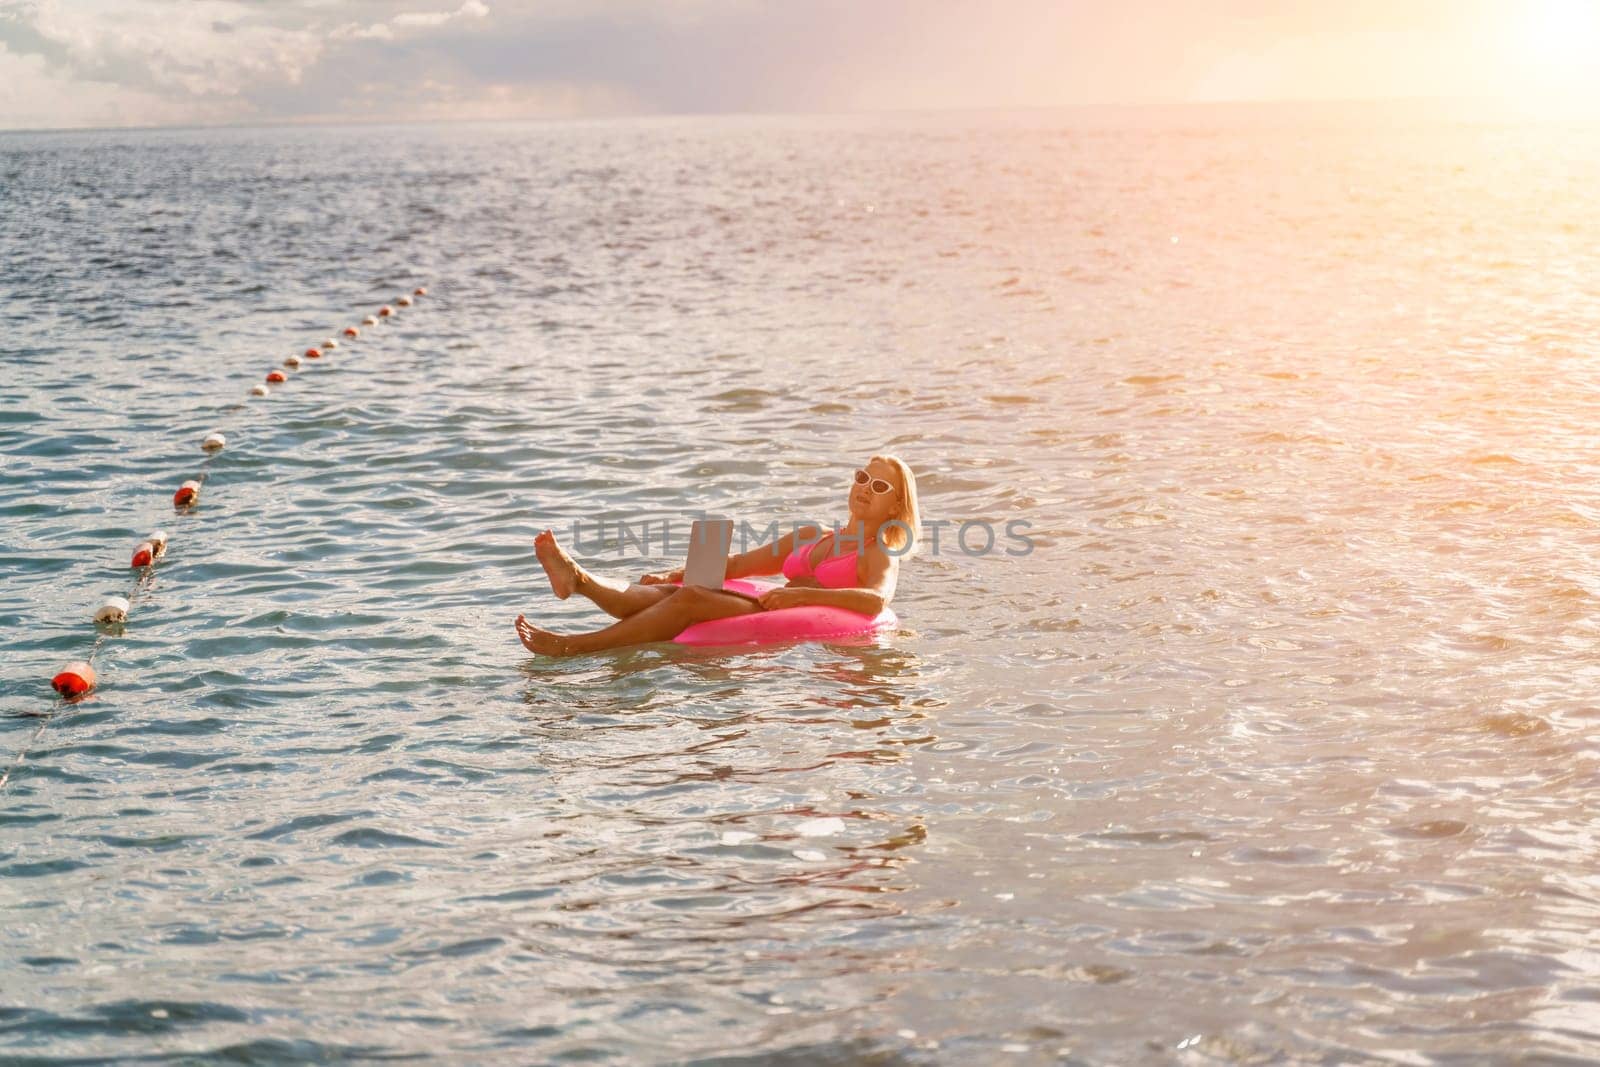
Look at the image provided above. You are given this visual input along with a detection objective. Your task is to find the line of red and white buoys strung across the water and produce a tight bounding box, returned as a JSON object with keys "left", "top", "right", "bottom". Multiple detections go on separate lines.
{"left": 0, "top": 285, "right": 427, "bottom": 793}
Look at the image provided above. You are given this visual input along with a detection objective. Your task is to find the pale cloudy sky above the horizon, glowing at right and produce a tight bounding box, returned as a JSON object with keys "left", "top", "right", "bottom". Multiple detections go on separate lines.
{"left": 0, "top": 0, "right": 1600, "bottom": 128}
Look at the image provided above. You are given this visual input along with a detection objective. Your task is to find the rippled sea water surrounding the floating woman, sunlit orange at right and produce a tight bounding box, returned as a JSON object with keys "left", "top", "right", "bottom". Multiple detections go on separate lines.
{"left": 0, "top": 107, "right": 1600, "bottom": 1064}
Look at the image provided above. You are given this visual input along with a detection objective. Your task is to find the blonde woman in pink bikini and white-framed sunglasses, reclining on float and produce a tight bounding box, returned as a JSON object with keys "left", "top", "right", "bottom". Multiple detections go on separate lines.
{"left": 517, "top": 456, "right": 918, "bottom": 656}
